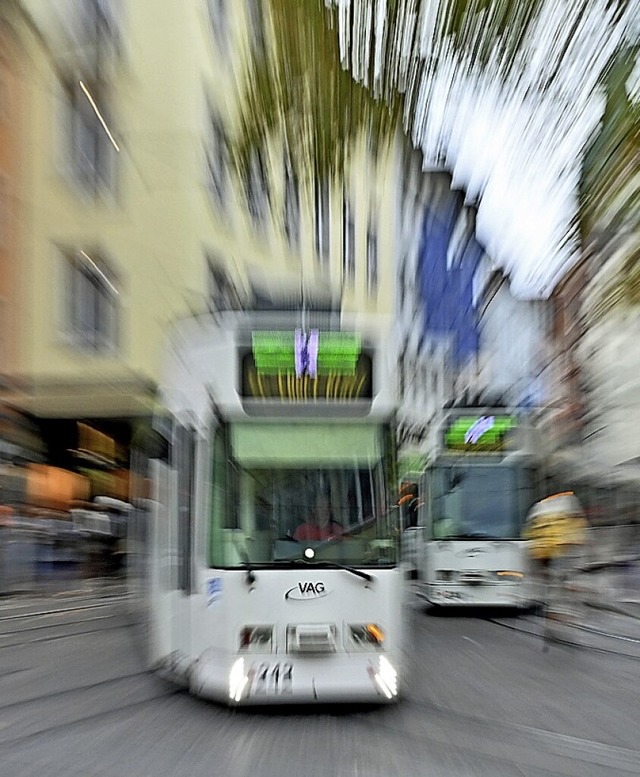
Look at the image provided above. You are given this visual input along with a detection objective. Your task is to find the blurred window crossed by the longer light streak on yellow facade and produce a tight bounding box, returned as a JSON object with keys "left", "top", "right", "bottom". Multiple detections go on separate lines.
{"left": 63, "top": 80, "right": 117, "bottom": 194}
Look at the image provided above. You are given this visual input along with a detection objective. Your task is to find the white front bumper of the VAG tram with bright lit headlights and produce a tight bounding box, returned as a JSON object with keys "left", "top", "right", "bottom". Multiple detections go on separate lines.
{"left": 193, "top": 654, "right": 398, "bottom": 706}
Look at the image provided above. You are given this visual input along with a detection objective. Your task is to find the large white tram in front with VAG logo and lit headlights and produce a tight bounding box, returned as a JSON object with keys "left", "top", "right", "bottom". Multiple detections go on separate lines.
{"left": 148, "top": 312, "right": 403, "bottom": 705}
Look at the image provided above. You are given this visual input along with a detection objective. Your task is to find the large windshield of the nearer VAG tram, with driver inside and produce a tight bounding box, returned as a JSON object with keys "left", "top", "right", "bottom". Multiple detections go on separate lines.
{"left": 210, "top": 423, "right": 398, "bottom": 567}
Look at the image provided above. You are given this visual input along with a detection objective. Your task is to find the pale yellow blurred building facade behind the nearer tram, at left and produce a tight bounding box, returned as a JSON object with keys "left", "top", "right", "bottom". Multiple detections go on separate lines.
{"left": 0, "top": 0, "right": 403, "bottom": 506}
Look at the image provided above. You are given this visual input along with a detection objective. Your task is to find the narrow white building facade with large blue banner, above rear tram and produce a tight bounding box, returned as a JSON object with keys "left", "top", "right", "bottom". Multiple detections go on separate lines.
{"left": 397, "top": 161, "right": 485, "bottom": 470}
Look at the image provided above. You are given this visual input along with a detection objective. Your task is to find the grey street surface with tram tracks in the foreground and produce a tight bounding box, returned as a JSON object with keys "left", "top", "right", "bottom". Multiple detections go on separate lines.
{"left": 0, "top": 596, "right": 640, "bottom": 777}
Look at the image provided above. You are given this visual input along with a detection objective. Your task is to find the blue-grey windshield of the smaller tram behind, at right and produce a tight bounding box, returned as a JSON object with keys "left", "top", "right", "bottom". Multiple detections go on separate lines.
{"left": 430, "top": 464, "right": 533, "bottom": 540}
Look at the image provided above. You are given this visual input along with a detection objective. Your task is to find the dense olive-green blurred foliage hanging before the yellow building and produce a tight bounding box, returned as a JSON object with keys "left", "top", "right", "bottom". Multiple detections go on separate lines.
{"left": 231, "top": 0, "right": 402, "bottom": 180}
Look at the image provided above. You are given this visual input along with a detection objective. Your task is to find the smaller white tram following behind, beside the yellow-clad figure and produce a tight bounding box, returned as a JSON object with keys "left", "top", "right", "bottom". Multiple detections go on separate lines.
{"left": 410, "top": 408, "right": 539, "bottom": 607}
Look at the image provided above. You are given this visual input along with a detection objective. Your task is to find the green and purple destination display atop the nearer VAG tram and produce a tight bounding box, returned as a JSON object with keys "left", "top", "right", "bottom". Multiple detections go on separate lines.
{"left": 240, "top": 329, "right": 373, "bottom": 402}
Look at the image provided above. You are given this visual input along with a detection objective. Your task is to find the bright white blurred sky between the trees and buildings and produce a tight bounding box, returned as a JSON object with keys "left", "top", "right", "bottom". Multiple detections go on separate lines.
{"left": 333, "top": 0, "right": 640, "bottom": 298}
